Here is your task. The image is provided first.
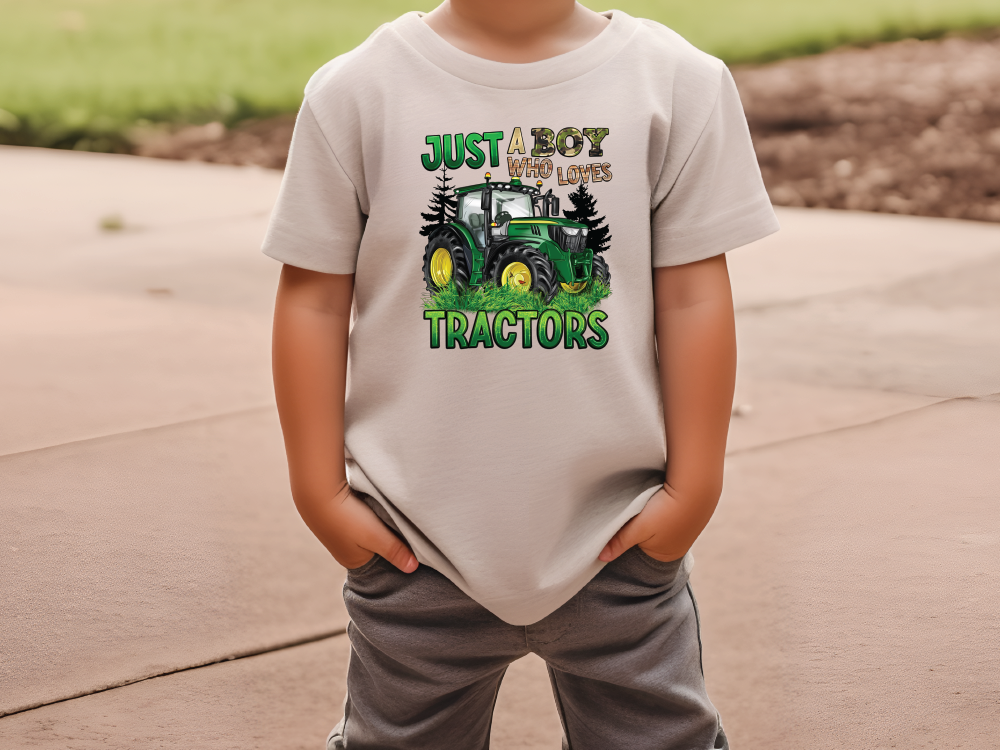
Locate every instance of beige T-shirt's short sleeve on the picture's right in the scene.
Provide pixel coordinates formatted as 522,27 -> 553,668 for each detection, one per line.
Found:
651,66 -> 779,267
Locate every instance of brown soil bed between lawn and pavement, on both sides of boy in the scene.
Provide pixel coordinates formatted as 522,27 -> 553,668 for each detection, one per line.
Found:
136,34 -> 1000,221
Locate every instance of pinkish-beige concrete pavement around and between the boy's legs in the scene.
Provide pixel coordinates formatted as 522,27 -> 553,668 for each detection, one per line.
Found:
0,148 -> 1000,750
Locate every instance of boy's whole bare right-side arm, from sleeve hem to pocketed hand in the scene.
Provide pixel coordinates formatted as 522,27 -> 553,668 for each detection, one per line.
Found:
600,254 -> 736,562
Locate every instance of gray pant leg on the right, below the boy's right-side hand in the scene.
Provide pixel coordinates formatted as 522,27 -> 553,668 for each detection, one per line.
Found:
528,547 -> 728,750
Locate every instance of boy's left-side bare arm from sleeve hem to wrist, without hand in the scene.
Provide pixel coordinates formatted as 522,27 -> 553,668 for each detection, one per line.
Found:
272,266 -> 354,516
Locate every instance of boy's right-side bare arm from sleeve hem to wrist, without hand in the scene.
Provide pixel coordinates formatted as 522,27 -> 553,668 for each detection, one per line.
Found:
654,255 -> 736,524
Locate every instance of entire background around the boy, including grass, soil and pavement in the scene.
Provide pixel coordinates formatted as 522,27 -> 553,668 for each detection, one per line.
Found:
0,0 -> 1000,750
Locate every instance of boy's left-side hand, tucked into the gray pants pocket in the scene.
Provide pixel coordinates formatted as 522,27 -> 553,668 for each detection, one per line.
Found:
300,485 -> 418,573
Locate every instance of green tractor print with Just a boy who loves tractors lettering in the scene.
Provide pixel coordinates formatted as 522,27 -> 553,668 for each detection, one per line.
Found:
420,127 -> 613,349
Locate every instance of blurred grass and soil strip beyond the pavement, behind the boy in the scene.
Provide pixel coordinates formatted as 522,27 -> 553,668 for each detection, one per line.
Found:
0,0 -> 1000,221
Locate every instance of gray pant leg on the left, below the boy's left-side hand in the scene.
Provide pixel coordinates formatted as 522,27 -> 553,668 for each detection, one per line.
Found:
327,556 -> 527,750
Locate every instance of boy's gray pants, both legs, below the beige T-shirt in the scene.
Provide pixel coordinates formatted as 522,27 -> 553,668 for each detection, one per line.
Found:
327,547 -> 729,750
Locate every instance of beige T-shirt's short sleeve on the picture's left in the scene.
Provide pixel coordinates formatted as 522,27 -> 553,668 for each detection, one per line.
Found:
261,100 -> 366,273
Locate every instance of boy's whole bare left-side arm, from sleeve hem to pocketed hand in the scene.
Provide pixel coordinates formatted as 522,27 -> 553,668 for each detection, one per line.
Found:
272,265 -> 417,573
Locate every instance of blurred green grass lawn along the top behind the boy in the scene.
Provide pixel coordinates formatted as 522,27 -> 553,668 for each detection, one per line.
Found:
0,0 -> 1000,150
